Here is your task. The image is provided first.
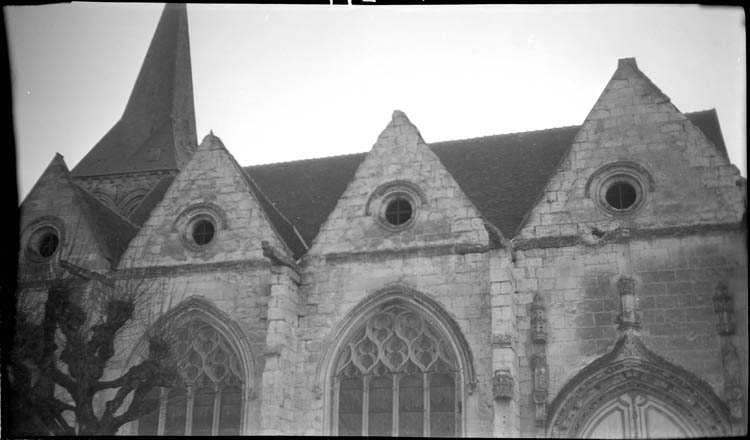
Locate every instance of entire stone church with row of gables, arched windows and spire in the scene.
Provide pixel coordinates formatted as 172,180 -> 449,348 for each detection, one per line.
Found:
18,5 -> 748,437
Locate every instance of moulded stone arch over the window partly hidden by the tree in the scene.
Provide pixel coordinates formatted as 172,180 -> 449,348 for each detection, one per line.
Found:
122,295 -> 261,434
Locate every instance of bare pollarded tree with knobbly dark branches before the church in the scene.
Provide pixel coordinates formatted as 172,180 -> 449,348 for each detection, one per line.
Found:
6,261 -> 180,435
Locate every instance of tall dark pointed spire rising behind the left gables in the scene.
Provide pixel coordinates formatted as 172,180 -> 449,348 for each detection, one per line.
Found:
72,4 -> 197,177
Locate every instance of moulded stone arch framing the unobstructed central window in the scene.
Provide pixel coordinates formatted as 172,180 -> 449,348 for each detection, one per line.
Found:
314,284 -> 477,435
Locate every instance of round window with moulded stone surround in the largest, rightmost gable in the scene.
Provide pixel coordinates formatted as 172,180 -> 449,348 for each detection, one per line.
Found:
586,162 -> 653,215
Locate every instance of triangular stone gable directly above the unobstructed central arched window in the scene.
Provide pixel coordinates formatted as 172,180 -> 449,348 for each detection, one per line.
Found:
309,110 -> 489,254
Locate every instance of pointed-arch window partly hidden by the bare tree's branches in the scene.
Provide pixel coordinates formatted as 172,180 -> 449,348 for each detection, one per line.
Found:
138,318 -> 243,435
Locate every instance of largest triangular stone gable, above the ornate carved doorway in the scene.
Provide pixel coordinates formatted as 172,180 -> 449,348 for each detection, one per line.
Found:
521,58 -> 743,238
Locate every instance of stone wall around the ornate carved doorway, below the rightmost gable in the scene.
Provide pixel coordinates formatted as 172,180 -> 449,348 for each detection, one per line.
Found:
512,232 -> 748,434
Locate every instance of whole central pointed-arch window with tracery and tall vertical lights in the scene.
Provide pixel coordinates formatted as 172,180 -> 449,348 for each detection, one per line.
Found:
333,303 -> 461,437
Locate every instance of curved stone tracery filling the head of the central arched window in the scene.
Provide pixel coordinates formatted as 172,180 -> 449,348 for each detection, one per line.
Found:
336,305 -> 456,376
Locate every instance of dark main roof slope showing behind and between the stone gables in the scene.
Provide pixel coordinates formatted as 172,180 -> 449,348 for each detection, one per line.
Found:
244,110 -> 727,248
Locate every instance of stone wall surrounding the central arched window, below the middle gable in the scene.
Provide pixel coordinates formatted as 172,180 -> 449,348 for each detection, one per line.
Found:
295,252 -> 500,436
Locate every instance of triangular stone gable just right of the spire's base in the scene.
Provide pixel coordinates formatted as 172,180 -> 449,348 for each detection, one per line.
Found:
120,134 -> 292,268
